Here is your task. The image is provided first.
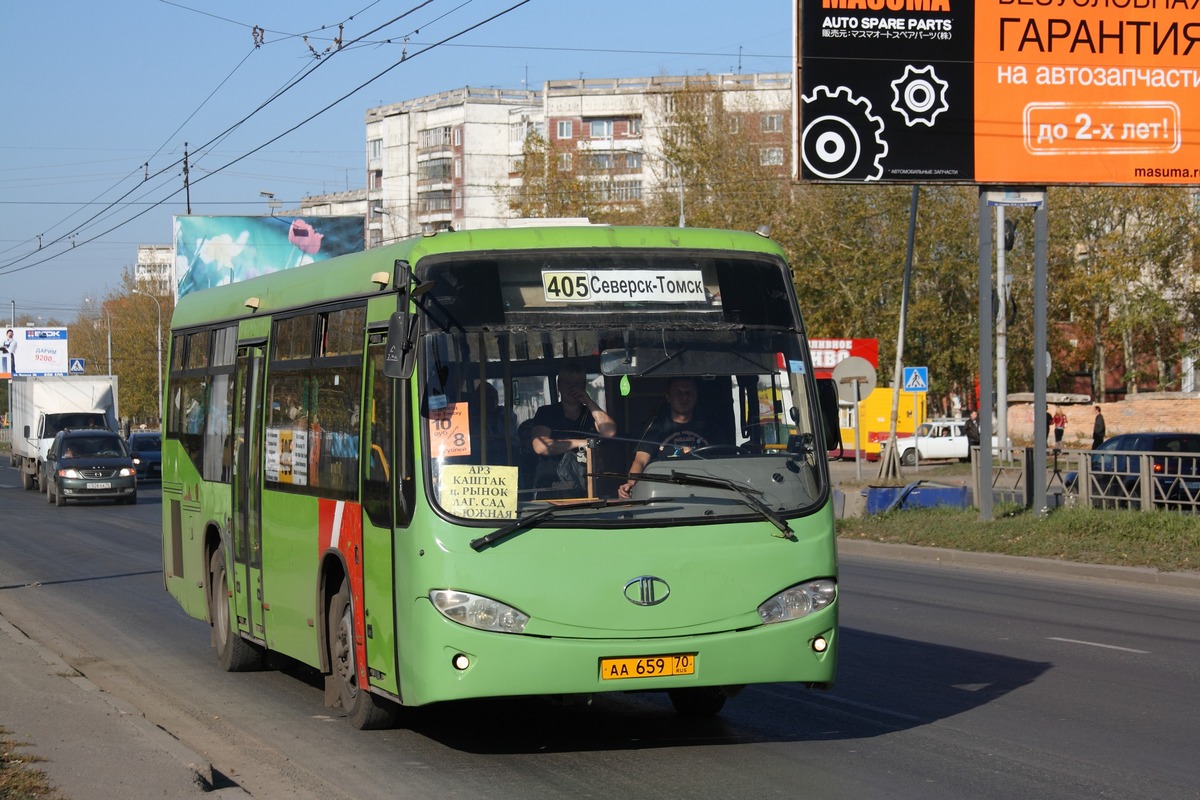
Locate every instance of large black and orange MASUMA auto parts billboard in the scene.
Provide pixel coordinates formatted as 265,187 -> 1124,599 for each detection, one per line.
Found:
794,0 -> 1200,186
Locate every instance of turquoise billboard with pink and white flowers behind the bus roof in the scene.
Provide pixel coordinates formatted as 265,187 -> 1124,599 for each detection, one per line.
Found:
174,216 -> 365,299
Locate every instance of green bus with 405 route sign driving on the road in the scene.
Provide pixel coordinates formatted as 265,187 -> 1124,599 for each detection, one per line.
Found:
162,225 -> 838,728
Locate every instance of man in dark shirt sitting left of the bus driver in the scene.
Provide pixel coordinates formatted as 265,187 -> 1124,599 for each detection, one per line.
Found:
530,361 -> 617,499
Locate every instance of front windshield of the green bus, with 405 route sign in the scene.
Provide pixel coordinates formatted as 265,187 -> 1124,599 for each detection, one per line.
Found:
419,251 -> 827,530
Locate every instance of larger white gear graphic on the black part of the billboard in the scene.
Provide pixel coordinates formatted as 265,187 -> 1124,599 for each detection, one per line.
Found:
800,86 -> 888,181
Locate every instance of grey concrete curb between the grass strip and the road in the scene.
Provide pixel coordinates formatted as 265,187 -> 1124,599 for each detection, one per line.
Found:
838,537 -> 1200,591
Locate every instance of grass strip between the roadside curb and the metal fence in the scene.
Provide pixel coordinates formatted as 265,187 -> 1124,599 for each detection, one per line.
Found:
838,506 -> 1200,572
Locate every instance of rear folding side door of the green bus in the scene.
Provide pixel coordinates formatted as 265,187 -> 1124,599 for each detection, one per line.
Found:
233,344 -> 266,642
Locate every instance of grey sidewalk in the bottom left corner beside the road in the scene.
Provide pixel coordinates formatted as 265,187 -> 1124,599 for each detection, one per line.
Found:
0,616 -> 250,800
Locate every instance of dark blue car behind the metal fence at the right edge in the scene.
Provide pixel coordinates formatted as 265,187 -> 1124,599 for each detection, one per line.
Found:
1063,432 -> 1200,505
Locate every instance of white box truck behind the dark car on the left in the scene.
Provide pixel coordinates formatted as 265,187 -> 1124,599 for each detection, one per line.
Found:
8,375 -> 120,489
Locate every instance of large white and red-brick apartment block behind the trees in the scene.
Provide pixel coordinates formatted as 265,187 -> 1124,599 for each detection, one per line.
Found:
360,73 -> 792,247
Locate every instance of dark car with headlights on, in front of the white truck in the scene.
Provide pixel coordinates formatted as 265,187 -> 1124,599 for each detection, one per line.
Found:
38,428 -> 138,506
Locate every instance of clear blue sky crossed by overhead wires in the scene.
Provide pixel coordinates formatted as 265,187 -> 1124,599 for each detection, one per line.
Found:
0,0 -> 792,321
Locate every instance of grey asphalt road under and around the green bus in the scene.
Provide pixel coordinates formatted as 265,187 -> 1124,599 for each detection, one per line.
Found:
0,465 -> 1200,800
